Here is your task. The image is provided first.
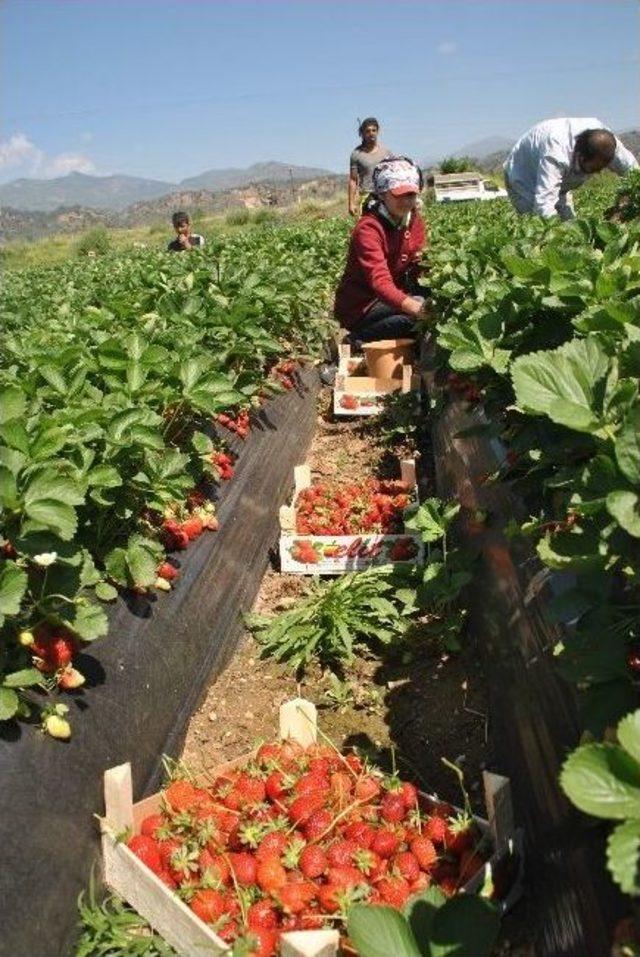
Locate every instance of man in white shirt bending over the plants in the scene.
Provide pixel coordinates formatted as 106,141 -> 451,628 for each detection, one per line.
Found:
504,117 -> 638,220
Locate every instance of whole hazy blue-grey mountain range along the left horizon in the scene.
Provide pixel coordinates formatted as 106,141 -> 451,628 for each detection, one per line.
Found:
0,162 -> 338,212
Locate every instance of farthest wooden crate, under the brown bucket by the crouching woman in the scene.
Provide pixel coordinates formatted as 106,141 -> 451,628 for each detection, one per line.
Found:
333,345 -> 420,416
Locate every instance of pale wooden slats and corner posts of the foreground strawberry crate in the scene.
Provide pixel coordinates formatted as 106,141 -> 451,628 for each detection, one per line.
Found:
99,698 -> 521,957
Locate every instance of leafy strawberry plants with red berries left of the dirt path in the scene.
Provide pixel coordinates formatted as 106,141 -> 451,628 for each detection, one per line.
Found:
0,223 -> 344,736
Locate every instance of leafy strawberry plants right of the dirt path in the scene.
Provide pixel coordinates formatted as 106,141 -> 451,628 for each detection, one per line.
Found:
430,177 -> 640,893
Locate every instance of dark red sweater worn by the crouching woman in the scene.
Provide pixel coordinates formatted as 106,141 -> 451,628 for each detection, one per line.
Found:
334,211 -> 425,329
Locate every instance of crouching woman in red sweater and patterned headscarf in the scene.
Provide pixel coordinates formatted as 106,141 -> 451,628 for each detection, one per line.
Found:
334,156 -> 426,342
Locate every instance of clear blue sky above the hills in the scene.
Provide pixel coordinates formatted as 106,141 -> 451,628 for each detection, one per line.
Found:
0,0 -> 640,181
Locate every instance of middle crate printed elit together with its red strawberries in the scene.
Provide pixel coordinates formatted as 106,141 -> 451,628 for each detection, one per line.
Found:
280,459 -> 424,575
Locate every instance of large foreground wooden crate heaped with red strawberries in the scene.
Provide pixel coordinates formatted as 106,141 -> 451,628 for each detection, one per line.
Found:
101,699 -> 520,957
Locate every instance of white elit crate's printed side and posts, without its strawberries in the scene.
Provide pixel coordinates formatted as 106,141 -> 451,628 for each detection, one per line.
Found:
280,459 -> 424,575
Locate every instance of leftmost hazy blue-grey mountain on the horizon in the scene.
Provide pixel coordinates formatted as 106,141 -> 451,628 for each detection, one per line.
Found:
0,173 -> 174,212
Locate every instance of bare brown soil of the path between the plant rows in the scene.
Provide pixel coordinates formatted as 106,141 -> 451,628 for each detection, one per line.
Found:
182,389 -> 531,957
